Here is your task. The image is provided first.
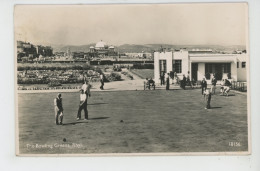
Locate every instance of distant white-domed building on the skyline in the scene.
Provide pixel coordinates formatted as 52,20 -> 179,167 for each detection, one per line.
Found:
89,40 -> 117,57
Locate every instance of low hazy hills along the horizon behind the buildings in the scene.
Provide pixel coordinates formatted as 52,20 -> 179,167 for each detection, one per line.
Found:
51,43 -> 246,53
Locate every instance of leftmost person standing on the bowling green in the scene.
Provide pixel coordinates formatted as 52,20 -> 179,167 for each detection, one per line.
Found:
54,93 -> 63,125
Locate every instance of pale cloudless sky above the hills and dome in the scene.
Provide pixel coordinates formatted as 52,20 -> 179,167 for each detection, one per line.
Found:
14,3 -> 248,45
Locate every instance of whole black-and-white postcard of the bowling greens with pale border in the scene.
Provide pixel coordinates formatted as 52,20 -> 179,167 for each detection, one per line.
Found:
14,3 -> 251,156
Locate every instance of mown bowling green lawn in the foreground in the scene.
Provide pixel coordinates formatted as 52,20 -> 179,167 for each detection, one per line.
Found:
18,89 -> 248,154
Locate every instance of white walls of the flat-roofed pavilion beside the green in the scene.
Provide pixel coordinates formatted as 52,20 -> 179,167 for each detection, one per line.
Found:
154,50 -> 248,83
